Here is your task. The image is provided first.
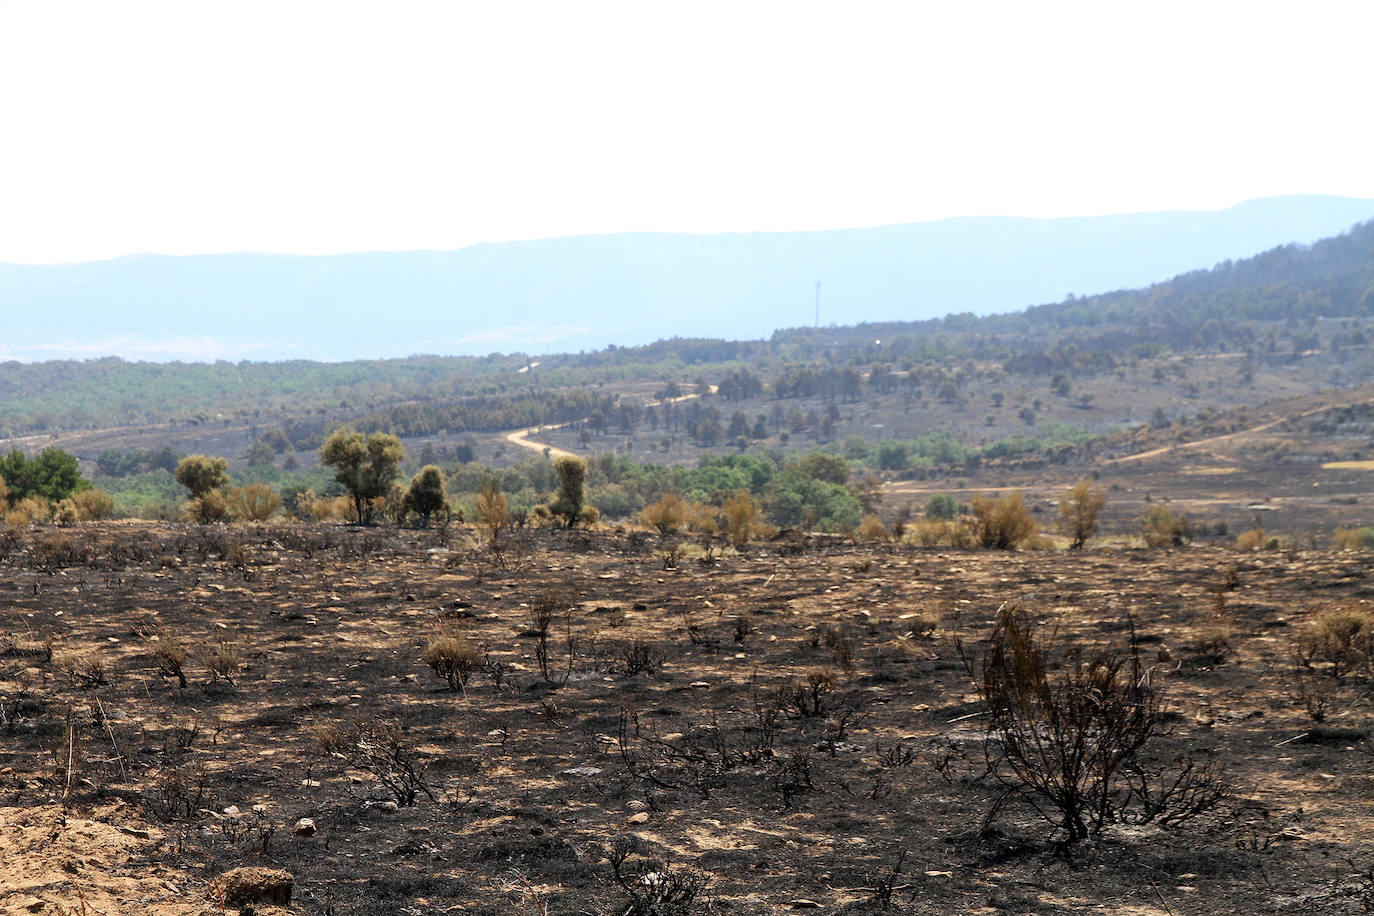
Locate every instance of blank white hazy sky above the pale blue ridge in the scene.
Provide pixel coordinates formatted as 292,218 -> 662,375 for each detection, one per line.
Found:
0,0 -> 1374,262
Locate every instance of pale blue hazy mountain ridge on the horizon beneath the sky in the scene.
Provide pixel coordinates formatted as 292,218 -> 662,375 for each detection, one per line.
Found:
8,196 -> 1374,361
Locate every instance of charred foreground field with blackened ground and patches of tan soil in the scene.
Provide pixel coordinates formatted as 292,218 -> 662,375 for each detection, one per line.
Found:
0,521 -> 1374,916
